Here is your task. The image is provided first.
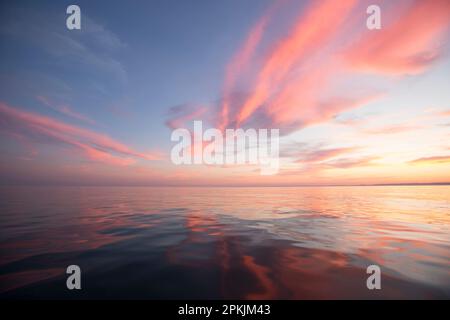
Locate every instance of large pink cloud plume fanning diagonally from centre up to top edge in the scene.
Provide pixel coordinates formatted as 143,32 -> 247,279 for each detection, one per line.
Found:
210,0 -> 381,134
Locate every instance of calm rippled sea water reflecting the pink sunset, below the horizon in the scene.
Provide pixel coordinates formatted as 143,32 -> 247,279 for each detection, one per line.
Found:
0,186 -> 450,299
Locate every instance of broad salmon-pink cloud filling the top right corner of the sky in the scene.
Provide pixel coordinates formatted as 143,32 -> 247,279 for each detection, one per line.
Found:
346,0 -> 450,75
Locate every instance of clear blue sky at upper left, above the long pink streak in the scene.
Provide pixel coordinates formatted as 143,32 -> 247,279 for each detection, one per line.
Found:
0,1 -> 274,148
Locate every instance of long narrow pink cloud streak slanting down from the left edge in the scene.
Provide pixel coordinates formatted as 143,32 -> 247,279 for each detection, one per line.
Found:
0,102 -> 162,165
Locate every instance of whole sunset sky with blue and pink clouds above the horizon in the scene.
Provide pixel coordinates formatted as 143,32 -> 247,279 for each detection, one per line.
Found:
0,0 -> 450,186
